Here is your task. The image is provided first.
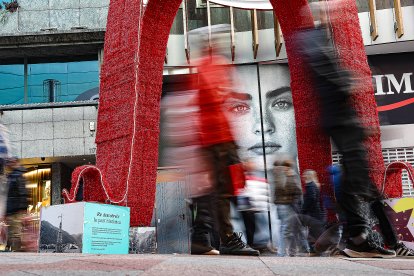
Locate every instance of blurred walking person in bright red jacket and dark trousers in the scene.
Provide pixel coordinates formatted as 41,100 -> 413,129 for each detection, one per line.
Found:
190,24 -> 259,256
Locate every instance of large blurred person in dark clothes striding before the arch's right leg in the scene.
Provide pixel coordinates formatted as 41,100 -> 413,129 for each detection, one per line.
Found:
294,2 -> 395,258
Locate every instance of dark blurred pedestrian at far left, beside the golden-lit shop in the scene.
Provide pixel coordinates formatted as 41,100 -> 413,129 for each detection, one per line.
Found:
6,157 -> 28,251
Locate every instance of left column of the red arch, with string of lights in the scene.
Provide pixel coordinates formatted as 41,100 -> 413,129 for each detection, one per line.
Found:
96,0 -> 181,226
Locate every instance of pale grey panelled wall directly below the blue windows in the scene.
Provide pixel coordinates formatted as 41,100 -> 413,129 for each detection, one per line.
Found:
0,106 -> 97,158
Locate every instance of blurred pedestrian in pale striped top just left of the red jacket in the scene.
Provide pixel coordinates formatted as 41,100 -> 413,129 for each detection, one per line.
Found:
162,89 -> 219,255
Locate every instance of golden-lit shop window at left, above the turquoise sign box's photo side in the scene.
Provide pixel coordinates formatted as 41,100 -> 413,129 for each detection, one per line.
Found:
24,168 -> 51,215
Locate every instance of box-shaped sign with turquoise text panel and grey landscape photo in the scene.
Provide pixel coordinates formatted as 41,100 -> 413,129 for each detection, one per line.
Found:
39,202 -> 130,254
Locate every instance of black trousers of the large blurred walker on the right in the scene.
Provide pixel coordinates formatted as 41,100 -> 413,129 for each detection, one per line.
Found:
327,126 -> 379,237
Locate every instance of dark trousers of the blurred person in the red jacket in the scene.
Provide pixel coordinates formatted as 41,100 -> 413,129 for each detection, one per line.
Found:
206,142 -> 240,241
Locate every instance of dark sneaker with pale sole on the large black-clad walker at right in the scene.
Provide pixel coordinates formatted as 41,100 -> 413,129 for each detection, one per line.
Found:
343,238 -> 396,258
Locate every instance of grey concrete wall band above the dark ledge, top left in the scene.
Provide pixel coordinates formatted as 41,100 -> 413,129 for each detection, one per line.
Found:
0,0 -> 110,35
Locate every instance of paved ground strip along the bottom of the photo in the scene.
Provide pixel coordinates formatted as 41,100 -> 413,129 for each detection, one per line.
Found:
0,253 -> 414,276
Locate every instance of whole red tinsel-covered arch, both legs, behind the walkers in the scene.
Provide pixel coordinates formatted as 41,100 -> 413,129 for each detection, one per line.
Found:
67,0 -> 394,226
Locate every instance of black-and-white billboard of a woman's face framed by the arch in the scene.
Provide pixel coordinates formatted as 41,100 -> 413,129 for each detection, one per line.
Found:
225,64 -> 297,174
